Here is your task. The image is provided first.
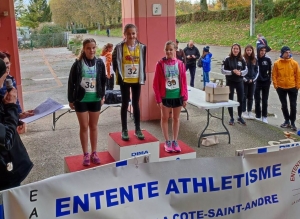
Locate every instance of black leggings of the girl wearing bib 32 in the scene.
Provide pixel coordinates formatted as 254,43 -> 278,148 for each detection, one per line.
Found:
120,83 -> 141,130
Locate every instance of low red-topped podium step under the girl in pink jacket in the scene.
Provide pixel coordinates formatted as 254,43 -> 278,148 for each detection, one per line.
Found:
159,140 -> 196,162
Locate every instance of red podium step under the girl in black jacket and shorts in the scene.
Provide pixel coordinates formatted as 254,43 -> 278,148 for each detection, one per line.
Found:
64,151 -> 115,173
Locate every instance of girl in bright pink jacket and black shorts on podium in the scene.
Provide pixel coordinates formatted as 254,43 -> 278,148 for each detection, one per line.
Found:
153,41 -> 188,152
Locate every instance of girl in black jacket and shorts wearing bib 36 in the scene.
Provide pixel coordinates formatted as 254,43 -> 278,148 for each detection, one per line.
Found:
68,38 -> 106,166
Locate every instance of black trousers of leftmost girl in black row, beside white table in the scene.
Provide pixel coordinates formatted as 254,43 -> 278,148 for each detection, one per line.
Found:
226,80 -> 244,119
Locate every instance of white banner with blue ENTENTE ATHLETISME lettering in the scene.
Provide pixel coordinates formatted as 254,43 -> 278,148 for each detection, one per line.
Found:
4,147 -> 300,219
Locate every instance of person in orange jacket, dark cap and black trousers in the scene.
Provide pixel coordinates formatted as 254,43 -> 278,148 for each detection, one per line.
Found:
272,46 -> 300,131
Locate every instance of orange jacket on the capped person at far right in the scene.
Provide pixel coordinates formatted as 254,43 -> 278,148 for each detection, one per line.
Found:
272,58 -> 300,89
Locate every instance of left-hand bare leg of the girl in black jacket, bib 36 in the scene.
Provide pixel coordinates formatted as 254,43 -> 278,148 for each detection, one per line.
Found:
76,112 -> 89,154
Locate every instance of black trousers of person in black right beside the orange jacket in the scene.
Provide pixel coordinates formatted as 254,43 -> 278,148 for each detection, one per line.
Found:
254,81 -> 271,118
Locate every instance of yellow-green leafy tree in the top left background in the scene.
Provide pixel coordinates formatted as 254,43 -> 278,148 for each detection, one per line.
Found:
20,0 -> 52,28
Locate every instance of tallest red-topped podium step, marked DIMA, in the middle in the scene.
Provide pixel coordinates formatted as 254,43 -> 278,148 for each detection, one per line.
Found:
108,130 -> 159,162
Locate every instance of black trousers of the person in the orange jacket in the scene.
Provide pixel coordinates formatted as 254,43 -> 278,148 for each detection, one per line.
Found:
276,88 -> 298,124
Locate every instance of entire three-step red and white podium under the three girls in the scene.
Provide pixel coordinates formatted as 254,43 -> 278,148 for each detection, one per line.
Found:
64,130 -> 196,173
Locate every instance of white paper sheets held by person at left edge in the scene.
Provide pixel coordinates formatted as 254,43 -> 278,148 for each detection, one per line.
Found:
21,98 -> 63,123
